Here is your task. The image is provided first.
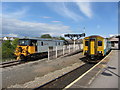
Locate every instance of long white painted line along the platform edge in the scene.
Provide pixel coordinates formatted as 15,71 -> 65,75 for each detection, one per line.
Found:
63,51 -> 112,90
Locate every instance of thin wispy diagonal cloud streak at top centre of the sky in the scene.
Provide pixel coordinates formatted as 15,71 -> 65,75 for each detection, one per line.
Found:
47,2 -> 82,21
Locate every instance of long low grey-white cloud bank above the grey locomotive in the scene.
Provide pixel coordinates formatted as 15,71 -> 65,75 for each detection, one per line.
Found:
2,18 -> 71,37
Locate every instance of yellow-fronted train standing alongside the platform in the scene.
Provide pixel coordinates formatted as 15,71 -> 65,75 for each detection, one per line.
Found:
83,35 -> 111,59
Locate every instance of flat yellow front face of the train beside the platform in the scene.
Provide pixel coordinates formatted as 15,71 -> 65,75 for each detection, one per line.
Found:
83,36 -> 104,60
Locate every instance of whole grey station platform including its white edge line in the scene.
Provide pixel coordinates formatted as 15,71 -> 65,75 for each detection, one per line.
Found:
65,50 -> 120,90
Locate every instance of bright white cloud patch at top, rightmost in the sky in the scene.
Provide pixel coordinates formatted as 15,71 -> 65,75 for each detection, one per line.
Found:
76,2 -> 93,18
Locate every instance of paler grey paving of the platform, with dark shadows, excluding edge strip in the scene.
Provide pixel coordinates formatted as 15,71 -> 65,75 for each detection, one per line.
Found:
90,50 -> 120,88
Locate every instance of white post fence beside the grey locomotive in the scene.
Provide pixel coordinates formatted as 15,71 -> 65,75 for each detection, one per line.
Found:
48,44 -> 83,60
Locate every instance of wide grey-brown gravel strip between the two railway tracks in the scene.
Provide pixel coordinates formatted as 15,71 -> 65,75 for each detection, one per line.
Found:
2,53 -> 84,88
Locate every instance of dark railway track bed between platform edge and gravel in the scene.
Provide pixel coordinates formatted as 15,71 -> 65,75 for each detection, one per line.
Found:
34,63 -> 95,90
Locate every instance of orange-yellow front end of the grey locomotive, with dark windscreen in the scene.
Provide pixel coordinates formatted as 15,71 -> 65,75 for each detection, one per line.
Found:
14,39 -> 35,60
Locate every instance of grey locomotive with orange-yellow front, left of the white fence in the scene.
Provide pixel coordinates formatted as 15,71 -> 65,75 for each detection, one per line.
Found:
14,38 -> 64,60
